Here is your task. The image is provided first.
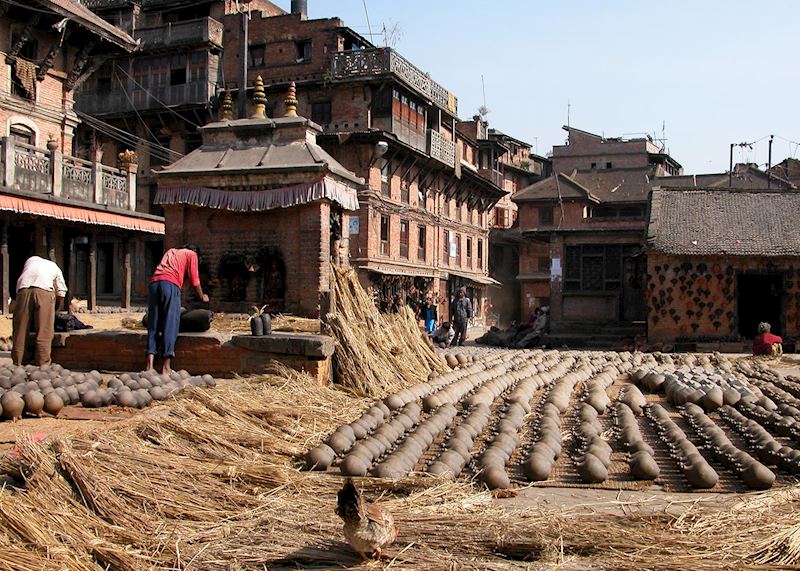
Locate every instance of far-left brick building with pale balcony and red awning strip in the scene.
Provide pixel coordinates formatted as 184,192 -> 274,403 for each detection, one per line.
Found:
0,0 -> 164,312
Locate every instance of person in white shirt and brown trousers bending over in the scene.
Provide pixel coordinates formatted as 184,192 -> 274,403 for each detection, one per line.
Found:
11,256 -> 67,366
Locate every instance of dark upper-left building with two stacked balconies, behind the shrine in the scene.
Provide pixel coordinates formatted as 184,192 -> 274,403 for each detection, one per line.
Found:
75,0 -> 285,213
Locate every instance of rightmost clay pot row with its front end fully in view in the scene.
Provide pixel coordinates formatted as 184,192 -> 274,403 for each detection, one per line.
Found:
684,403 -> 775,490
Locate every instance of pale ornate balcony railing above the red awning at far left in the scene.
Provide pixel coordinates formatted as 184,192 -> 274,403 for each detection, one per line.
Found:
0,137 -> 136,210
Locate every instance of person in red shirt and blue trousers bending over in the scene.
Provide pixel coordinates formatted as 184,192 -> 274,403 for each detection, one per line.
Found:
147,244 -> 208,374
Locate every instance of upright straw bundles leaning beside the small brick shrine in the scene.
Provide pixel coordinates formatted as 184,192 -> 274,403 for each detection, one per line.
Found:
328,267 -> 447,397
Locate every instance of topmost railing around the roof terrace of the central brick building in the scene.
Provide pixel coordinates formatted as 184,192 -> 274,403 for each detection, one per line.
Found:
331,48 -> 458,115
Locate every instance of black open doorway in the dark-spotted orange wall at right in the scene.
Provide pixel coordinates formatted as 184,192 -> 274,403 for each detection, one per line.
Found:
736,274 -> 783,339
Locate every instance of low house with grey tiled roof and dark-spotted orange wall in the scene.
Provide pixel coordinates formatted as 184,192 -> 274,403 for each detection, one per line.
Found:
647,188 -> 800,351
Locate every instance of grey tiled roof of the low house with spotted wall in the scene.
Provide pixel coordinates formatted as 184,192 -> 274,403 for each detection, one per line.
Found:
647,189 -> 800,257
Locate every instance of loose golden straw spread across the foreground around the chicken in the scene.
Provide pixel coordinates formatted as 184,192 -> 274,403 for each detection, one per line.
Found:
0,370 -> 800,571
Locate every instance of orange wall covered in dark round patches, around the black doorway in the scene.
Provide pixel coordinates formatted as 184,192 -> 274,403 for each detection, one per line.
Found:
647,252 -> 800,342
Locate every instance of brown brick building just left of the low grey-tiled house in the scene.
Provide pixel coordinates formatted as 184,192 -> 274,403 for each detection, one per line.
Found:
511,127 -> 681,327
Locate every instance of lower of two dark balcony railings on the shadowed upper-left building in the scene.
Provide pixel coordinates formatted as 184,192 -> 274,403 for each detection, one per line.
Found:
75,81 -> 214,115
